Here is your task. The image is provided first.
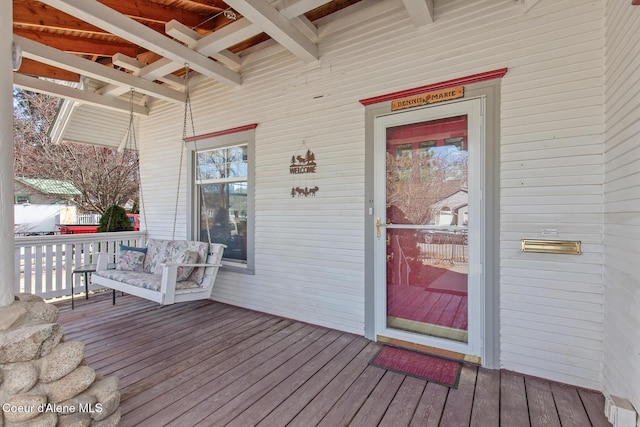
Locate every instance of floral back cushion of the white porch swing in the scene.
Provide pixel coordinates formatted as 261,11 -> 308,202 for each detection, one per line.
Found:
143,239 -> 209,284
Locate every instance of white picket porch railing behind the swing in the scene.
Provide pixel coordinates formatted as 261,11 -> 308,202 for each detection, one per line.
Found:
14,231 -> 145,299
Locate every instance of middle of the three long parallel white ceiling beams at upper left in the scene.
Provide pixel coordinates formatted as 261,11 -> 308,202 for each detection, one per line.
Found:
13,36 -> 184,103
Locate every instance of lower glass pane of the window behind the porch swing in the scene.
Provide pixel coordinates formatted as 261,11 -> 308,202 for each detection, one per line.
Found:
199,182 -> 247,263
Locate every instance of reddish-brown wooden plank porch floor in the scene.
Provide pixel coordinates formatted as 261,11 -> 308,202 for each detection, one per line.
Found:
57,293 -> 610,427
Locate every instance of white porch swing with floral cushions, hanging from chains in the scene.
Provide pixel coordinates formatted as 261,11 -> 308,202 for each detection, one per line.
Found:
91,65 -> 226,305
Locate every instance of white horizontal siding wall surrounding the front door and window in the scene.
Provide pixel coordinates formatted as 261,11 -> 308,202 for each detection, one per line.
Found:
141,0 -> 604,388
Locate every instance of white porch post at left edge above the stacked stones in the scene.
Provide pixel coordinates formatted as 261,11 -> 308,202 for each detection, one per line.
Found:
0,0 -> 15,307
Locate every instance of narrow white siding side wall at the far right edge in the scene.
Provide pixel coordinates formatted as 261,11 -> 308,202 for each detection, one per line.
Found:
604,1 -> 640,410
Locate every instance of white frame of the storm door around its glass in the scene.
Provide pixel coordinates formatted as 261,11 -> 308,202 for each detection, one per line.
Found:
374,98 -> 484,358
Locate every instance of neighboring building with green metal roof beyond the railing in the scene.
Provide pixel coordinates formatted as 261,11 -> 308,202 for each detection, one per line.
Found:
14,177 -> 82,205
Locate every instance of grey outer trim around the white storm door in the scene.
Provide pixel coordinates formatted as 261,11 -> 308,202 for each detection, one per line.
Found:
364,75 -> 503,368
